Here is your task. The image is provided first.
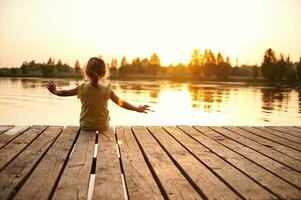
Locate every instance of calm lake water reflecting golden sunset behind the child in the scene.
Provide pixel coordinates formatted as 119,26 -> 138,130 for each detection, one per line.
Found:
0,78 -> 301,125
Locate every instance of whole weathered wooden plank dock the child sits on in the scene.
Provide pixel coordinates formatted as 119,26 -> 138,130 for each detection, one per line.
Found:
0,125 -> 301,200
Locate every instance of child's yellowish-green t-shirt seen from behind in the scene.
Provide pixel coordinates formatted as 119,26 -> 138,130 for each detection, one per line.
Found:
77,83 -> 111,129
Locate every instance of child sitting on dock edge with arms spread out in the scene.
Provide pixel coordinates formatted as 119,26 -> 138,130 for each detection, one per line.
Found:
46,57 -> 149,131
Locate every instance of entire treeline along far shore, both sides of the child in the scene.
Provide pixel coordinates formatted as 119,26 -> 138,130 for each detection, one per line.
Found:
0,49 -> 301,82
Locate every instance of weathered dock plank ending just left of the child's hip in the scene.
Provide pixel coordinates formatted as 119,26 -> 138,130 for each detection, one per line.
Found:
14,126 -> 79,200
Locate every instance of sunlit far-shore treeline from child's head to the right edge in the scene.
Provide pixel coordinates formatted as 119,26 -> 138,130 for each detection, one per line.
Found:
110,49 -> 301,82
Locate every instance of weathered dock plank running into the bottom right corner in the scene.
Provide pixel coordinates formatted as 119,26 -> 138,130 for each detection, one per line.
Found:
180,126 -> 301,199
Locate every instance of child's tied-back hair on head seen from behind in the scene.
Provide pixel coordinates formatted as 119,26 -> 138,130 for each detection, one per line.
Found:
86,57 -> 107,85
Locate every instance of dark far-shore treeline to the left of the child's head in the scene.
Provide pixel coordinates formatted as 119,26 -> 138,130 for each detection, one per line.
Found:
0,57 -> 82,77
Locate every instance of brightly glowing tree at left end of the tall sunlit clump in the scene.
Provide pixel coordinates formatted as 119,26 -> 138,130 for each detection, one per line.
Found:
188,49 -> 202,79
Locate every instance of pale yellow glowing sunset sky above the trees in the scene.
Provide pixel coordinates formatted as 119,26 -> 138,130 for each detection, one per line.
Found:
0,0 -> 301,67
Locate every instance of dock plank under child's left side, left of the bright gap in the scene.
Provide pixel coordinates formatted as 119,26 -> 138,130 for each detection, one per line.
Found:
52,130 -> 95,200
